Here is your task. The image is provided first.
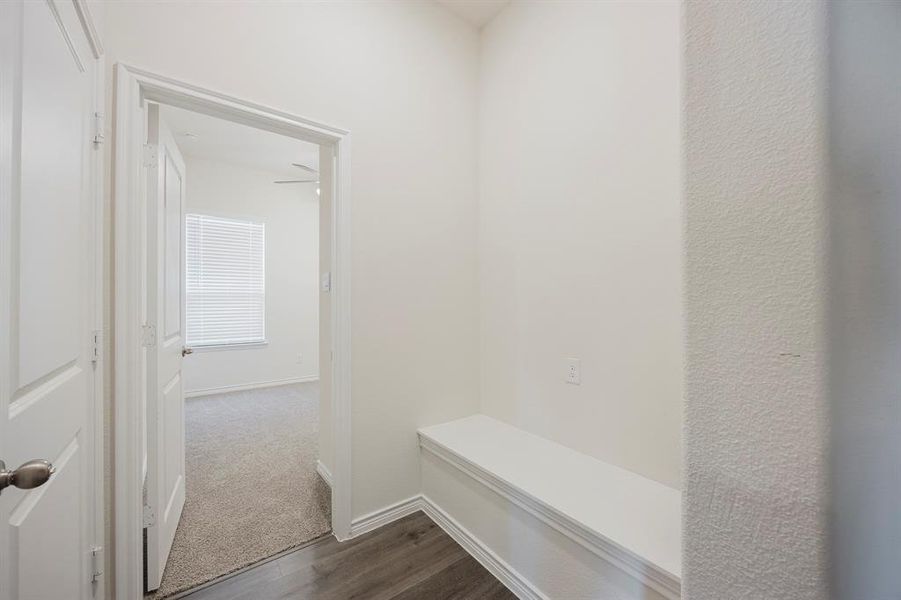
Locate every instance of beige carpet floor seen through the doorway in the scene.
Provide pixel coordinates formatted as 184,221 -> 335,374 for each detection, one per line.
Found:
148,383 -> 331,600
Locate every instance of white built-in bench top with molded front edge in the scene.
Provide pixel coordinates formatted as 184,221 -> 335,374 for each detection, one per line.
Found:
419,415 -> 681,598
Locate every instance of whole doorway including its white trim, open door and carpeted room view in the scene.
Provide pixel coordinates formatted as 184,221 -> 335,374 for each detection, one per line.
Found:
115,66 -> 350,598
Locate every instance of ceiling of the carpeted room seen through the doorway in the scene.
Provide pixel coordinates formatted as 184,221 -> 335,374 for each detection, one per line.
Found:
160,105 -> 319,179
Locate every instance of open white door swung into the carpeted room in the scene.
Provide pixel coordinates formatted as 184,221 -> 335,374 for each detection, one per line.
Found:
146,104 -> 185,591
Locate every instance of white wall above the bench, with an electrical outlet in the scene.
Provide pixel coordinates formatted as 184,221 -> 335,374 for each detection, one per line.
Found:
479,2 -> 682,487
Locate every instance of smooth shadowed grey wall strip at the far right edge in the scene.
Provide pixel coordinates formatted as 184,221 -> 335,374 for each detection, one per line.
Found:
828,1 -> 901,600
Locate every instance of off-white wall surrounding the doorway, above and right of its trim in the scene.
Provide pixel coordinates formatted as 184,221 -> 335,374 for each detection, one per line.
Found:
103,0 -> 478,516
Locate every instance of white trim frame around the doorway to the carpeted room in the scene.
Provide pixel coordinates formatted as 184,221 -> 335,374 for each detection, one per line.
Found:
113,63 -> 351,600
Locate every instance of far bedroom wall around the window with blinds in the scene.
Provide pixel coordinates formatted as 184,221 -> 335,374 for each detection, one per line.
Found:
184,156 -> 319,394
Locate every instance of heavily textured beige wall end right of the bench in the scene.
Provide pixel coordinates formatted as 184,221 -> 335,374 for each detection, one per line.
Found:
683,1 -> 828,600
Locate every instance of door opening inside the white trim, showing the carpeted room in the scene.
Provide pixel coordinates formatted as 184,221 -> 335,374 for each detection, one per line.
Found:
143,103 -> 331,598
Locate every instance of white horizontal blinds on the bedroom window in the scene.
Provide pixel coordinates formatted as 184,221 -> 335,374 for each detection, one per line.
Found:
185,214 -> 266,346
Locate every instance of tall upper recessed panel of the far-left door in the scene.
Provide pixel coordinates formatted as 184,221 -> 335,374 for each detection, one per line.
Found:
18,2 -> 91,386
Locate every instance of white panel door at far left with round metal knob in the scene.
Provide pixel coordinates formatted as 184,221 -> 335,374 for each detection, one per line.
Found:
0,0 -> 99,600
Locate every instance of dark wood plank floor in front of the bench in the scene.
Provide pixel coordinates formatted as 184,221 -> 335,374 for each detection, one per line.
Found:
184,513 -> 515,600
